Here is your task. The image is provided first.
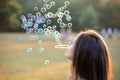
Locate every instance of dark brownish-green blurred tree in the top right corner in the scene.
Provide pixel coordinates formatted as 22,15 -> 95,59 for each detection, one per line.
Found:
99,0 -> 120,28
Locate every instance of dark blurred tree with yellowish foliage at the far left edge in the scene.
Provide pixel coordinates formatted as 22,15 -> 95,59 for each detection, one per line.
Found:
0,0 -> 20,31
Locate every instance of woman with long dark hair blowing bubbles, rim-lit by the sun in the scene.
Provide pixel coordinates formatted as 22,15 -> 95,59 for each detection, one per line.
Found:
65,30 -> 111,80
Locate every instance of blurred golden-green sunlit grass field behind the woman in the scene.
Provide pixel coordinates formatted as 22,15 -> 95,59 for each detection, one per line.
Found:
0,33 -> 120,80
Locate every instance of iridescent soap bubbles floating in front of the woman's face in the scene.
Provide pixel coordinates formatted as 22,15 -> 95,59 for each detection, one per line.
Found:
21,0 -> 72,64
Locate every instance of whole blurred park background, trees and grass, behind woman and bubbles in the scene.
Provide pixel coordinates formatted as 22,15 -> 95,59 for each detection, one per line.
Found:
0,0 -> 120,80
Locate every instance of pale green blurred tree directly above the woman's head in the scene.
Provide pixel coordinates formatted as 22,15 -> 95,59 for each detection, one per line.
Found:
79,6 -> 98,29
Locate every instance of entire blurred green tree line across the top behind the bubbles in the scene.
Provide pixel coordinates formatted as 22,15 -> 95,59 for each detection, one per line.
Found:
0,0 -> 120,31
